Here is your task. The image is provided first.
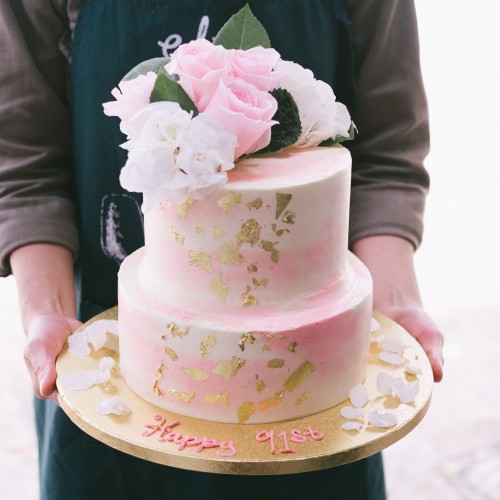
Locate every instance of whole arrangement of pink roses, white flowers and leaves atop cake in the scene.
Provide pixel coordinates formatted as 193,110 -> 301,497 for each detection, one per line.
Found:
103,5 -> 355,208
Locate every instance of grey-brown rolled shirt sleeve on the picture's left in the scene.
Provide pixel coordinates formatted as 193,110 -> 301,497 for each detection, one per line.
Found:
0,0 -> 78,276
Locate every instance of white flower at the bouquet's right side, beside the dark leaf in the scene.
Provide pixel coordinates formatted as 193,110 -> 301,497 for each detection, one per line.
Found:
274,61 -> 351,147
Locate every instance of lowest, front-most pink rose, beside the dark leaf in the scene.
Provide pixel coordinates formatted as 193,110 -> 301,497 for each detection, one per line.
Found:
205,78 -> 278,159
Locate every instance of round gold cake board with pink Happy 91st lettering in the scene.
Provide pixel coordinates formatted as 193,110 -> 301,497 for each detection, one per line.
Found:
56,307 -> 433,475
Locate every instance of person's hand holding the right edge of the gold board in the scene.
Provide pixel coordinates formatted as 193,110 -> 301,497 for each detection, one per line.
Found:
377,306 -> 444,382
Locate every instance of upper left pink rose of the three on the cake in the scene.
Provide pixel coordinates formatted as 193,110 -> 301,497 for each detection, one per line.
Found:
165,38 -> 231,112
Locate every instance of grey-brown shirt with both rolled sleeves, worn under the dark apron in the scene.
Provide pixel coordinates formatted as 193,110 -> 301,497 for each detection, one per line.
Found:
0,0 -> 429,276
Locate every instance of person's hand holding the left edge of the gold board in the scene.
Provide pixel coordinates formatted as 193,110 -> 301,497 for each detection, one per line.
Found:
24,314 -> 81,403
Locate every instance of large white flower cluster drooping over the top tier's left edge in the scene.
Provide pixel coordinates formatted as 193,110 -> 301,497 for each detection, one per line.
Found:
120,101 -> 236,212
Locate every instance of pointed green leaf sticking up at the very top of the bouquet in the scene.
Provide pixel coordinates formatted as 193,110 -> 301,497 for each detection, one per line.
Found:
214,4 -> 271,50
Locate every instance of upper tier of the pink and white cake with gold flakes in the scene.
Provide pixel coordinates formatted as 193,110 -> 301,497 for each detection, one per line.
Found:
139,147 -> 351,314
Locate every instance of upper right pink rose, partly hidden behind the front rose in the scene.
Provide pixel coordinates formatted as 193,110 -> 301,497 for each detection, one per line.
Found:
229,47 -> 283,92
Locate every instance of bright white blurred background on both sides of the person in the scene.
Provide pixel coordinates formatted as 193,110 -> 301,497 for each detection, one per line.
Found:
0,0 -> 500,500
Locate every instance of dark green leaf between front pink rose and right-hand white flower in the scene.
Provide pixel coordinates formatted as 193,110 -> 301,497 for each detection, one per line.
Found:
253,89 -> 302,155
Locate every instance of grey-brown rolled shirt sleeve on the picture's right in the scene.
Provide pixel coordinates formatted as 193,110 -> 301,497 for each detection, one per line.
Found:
344,0 -> 429,248
